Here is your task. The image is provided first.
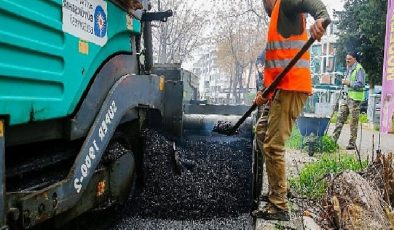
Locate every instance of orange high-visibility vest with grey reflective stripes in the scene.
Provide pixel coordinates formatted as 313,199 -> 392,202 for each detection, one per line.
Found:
264,0 -> 312,95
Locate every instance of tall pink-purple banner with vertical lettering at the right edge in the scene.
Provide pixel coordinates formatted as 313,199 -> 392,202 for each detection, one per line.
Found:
380,0 -> 394,133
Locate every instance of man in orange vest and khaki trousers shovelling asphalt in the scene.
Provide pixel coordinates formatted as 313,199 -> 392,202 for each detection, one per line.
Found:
252,0 -> 330,221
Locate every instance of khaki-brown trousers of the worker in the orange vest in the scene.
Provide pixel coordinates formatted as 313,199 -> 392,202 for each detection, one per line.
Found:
256,91 -> 308,210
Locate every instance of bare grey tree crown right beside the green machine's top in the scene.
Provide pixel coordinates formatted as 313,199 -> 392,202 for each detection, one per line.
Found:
152,0 -> 207,63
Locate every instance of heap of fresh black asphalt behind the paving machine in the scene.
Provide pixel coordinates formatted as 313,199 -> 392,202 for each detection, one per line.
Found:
113,130 -> 252,229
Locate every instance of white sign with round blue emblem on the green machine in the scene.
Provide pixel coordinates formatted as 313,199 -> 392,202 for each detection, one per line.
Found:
62,0 -> 108,46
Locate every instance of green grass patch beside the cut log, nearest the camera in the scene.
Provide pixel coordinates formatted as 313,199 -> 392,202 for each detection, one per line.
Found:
289,154 -> 368,199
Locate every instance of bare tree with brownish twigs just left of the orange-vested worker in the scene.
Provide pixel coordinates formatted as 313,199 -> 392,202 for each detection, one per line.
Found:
214,0 -> 268,103
